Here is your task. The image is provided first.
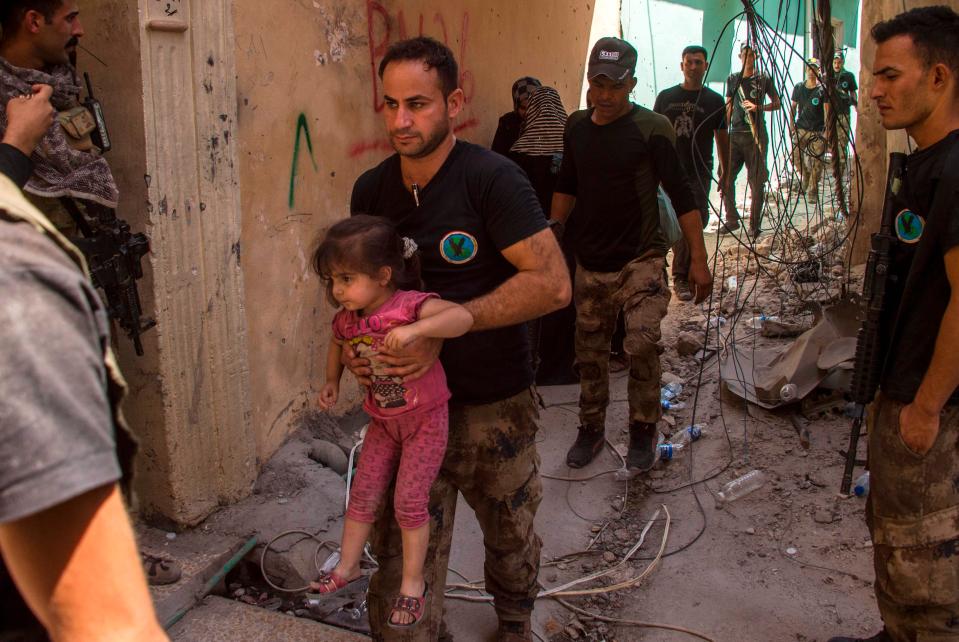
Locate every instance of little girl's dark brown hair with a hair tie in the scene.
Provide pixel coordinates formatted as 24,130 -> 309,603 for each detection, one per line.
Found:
310,214 -> 423,306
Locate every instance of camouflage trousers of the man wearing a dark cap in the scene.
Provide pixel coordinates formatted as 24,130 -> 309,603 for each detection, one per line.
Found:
573,256 -> 670,428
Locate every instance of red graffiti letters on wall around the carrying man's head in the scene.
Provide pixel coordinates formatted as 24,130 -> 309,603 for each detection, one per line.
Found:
366,0 -> 474,112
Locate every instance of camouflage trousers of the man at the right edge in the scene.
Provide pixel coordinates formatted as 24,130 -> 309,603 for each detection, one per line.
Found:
866,396 -> 959,642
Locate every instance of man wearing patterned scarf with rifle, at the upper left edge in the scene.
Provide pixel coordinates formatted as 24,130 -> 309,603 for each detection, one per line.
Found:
0,0 -> 181,597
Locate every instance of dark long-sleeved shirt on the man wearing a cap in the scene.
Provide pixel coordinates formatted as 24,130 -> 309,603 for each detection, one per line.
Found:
556,105 -> 697,272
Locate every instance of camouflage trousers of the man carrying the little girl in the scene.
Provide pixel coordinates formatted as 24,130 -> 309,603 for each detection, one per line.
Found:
367,390 -> 543,641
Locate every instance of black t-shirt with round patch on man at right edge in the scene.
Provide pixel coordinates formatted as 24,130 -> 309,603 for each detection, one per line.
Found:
881,130 -> 959,403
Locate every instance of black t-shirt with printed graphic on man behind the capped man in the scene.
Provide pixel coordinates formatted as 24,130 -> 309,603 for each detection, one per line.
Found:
653,85 -> 726,178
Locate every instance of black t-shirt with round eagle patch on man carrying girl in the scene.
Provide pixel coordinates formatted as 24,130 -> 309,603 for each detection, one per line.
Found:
350,141 -> 546,404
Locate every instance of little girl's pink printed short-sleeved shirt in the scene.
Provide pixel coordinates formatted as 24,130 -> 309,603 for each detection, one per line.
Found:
333,290 -> 450,419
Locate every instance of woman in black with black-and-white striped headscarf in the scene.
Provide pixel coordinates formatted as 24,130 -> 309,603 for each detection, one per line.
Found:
509,87 -> 578,385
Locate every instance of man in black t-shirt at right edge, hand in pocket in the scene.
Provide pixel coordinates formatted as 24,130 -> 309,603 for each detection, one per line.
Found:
830,7 -> 959,642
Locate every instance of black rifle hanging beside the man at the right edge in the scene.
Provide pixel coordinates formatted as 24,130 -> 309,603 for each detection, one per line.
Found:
840,152 -> 906,495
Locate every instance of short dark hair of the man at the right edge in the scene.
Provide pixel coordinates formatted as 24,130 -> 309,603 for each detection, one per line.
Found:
872,6 -> 959,76
